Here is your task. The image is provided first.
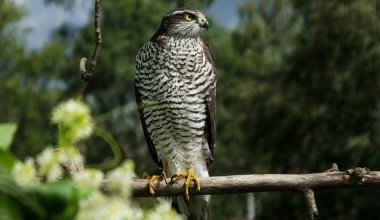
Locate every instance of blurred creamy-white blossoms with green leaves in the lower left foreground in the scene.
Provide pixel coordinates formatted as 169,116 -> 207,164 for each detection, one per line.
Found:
0,100 -> 180,220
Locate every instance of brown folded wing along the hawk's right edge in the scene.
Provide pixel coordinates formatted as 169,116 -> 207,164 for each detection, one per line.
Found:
202,40 -> 216,167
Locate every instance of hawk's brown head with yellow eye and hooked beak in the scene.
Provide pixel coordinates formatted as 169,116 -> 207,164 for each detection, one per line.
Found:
158,8 -> 209,38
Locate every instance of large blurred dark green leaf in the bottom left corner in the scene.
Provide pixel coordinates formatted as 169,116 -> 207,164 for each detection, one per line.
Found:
0,173 -> 84,220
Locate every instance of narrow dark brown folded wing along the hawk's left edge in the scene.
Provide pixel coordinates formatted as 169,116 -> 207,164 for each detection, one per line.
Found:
135,85 -> 162,168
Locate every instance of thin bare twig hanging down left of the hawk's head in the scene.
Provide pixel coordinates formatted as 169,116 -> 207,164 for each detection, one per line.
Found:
77,0 -> 102,97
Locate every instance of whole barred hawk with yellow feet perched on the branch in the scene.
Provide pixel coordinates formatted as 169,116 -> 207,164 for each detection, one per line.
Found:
135,8 -> 216,219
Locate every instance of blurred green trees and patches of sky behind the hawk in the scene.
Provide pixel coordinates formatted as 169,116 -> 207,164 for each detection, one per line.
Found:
0,0 -> 380,219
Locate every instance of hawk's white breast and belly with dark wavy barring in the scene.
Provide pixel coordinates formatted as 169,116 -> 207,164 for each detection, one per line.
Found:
136,39 -> 215,161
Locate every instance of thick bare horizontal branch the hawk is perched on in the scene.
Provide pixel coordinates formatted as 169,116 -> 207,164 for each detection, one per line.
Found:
124,168 -> 374,219
